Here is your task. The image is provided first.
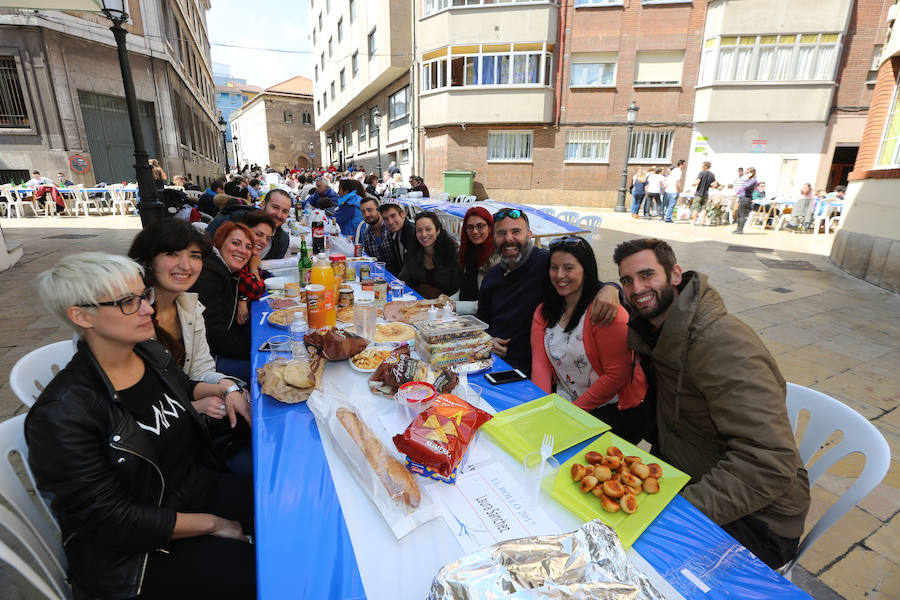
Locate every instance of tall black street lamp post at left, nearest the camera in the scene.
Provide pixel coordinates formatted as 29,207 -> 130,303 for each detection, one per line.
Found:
102,0 -> 163,227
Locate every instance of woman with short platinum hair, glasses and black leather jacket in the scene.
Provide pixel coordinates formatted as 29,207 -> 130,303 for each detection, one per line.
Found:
25,252 -> 256,600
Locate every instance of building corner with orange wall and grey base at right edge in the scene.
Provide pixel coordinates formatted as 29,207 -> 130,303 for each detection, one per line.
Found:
831,3 -> 900,292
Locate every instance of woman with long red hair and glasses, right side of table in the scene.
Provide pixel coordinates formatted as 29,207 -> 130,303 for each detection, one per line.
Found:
453,206 -> 499,315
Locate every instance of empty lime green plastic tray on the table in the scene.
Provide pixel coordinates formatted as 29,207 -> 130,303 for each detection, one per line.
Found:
481,394 -> 610,462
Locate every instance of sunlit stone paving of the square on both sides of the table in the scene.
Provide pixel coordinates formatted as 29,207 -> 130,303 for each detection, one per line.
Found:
0,213 -> 900,600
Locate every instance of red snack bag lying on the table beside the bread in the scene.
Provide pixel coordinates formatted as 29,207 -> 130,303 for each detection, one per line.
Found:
394,394 -> 491,477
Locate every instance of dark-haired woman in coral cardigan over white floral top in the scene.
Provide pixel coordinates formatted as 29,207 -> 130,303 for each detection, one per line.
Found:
531,237 -> 652,444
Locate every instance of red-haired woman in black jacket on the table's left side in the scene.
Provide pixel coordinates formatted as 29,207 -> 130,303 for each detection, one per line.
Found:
190,221 -> 253,381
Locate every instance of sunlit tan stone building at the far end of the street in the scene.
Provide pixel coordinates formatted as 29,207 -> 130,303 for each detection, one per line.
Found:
231,75 -> 320,170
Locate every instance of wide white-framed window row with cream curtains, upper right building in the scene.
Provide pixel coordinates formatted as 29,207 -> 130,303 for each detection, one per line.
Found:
700,31 -> 844,85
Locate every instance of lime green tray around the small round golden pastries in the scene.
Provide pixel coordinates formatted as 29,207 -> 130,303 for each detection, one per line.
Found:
550,432 -> 691,549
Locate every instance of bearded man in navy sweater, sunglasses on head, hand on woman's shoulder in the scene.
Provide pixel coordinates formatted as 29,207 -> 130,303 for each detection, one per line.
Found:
476,208 -> 620,376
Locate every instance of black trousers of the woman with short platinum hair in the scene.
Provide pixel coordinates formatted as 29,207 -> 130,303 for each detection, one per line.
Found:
137,473 -> 256,600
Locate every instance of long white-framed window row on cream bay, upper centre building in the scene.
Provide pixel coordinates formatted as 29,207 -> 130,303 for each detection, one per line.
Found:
422,44 -> 553,92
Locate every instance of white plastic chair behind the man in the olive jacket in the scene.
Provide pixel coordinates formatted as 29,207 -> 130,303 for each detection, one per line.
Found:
780,383 -> 891,576
